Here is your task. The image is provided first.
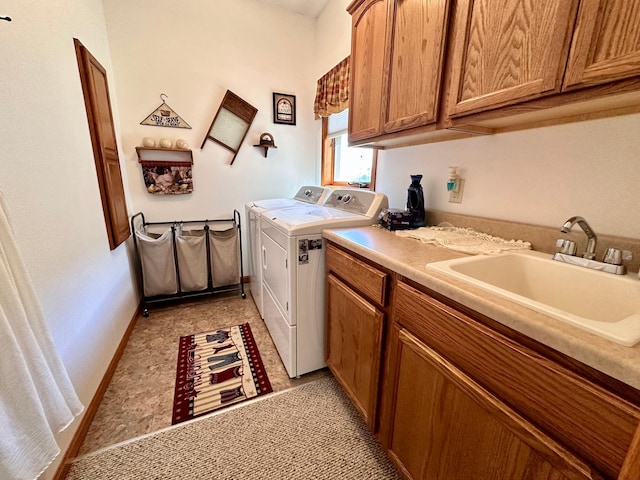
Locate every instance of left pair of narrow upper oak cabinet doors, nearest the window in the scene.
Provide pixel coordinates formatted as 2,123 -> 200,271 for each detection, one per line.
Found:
348,0 -> 450,143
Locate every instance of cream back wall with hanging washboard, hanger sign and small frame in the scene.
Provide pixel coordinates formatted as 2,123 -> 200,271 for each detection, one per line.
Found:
104,0 -> 319,229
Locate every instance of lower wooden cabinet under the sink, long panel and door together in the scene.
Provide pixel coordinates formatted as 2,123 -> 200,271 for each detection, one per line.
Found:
381,282 -> 640,479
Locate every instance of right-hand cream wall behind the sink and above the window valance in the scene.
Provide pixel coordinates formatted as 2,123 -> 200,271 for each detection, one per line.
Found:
318,0 -> 640,240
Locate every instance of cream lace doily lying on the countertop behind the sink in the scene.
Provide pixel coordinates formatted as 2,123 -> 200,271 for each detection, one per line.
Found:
396,227 -> 531,255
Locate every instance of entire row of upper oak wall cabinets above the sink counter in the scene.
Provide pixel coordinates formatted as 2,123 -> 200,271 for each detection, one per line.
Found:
347,0 -> 640,148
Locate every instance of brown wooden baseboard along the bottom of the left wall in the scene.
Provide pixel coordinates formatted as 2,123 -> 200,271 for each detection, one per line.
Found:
53,303 -> 142,480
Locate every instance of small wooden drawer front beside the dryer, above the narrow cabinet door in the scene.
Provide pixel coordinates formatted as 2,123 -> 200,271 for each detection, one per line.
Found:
327,245 -> 389,305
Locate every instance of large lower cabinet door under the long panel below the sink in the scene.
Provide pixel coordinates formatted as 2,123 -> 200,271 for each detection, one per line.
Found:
388,327 -> 598,480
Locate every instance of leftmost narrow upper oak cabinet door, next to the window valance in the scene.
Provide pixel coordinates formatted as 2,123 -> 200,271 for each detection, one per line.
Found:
349,0 -> 387,142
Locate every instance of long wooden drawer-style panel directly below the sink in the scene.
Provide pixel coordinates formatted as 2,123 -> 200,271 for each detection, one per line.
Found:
393,283 -> 640,478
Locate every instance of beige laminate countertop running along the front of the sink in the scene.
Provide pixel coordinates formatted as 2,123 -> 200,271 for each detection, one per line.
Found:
323,226 -> 640,389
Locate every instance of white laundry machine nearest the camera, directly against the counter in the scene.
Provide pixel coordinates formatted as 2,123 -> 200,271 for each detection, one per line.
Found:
261,189 -> 388,378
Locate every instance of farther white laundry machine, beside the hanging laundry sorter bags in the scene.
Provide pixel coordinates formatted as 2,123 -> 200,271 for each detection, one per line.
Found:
245,186 -> 331,318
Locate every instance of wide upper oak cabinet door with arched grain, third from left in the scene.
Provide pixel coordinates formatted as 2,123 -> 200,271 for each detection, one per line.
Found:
448,0 -> 578,117
